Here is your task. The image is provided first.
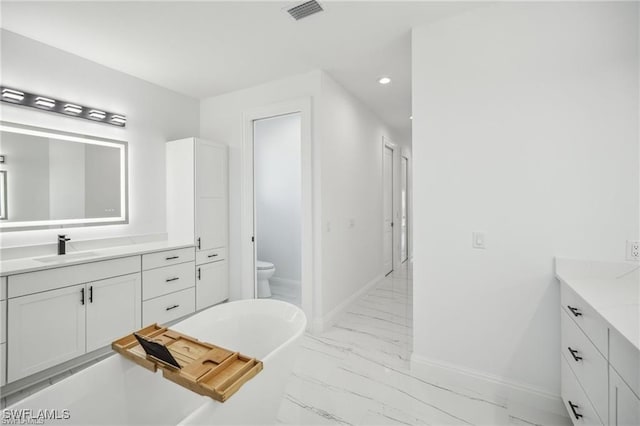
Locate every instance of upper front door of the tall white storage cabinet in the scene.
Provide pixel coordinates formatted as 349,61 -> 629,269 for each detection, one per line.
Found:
195,140 -> 228,250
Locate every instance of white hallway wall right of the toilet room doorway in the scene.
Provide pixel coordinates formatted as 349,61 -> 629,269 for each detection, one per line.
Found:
320,73 -> 400,325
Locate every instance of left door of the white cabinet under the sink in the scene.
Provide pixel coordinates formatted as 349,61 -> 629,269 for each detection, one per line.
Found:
7,284 -> 87,382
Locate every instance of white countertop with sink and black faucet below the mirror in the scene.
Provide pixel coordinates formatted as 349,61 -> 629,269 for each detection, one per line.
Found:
0,241 -> 194,276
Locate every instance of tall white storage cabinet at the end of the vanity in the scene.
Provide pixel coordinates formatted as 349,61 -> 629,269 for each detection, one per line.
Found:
167,138 -> 229,310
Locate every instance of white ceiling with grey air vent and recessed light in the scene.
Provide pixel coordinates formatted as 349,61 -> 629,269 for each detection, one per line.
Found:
0,1 -> 470,143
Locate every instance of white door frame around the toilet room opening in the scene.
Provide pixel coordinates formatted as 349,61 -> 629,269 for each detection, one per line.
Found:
240,97 -> 318,327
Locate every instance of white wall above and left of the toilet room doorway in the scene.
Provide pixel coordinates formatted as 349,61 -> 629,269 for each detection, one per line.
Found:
200,71 -> 320,300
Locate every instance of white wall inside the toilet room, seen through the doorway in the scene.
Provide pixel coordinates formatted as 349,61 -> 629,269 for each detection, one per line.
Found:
254,113 -> 302,285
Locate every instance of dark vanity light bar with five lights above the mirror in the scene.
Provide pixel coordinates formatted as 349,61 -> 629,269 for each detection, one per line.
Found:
0,86 -> 127,127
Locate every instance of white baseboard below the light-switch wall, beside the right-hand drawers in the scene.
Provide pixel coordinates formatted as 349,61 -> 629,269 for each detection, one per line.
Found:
411,353 -> 567,416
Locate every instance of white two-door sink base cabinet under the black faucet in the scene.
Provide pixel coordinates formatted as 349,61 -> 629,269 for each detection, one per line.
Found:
7,256 -> 141,382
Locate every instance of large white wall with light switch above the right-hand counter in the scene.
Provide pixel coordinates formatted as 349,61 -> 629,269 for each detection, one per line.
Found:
412,3 -> 640,395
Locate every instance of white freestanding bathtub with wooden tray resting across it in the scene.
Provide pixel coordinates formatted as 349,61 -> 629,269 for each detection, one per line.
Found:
3,299 -> 307,425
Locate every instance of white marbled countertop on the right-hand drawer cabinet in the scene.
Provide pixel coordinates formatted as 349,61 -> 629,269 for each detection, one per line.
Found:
556,258 -> 640,350
